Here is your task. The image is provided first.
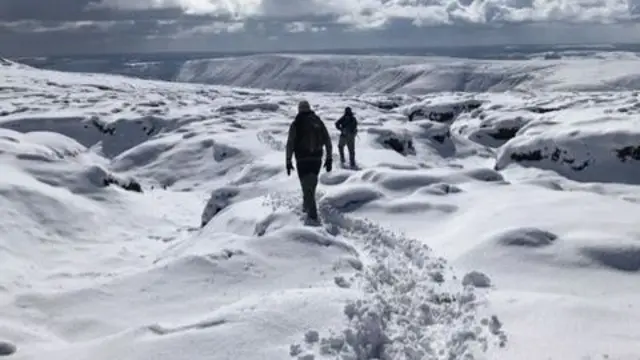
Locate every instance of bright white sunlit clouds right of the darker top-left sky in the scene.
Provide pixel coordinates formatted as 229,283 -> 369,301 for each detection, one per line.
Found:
92,0 -> 640,29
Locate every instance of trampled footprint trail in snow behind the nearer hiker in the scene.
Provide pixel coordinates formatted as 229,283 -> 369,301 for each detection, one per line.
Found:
266,193 -> 506,360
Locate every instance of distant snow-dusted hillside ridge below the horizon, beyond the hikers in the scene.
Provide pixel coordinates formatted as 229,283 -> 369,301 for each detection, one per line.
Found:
173,52 -> 640,95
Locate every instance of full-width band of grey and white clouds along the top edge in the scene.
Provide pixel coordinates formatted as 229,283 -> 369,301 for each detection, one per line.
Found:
0,0 -> 640,29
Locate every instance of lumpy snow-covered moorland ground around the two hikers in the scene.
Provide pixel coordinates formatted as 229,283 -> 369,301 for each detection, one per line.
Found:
0,57 -> 640,360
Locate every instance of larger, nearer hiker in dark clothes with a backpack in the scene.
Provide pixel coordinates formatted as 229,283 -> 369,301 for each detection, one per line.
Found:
286,100 -> 333,221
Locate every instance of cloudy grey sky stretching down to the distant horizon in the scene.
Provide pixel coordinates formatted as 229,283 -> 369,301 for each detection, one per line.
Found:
0,0 -> 640,56
